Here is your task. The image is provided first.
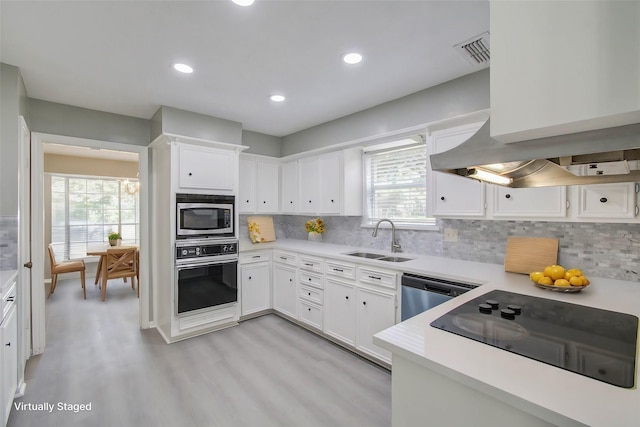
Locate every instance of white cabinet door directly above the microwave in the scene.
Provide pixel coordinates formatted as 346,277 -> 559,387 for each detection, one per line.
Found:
178,144 -> 238,192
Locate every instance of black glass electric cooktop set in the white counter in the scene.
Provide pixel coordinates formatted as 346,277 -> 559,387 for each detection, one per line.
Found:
431,290 -> 638,388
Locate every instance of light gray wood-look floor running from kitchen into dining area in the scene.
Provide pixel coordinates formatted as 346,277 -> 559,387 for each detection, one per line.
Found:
8,278 -> 391,427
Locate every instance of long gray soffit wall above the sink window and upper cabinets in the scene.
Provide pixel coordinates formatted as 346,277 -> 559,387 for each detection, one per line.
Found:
282,68 -> 489,156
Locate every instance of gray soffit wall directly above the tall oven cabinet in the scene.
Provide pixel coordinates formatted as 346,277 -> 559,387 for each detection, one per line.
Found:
151,106 -> 242,145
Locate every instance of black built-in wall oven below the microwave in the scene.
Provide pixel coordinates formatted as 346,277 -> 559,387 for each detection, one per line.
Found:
174,239 -> 238,317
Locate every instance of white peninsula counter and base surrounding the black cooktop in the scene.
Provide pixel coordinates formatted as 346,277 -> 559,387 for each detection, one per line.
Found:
374,275 -> 640,427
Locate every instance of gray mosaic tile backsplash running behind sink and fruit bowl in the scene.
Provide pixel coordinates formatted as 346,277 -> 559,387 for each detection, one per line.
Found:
240,215 -> 640,282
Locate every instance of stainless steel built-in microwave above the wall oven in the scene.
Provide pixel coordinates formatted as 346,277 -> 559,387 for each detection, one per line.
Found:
176,194 -> 235,239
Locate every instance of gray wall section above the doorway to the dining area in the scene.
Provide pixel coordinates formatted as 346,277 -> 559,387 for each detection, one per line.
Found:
29,99 -> 150,146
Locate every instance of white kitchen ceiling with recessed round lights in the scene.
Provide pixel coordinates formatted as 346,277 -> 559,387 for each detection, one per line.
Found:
0,0 -> 489,136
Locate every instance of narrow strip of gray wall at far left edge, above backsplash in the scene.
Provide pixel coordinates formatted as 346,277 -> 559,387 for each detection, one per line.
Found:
0,63 -> 29,216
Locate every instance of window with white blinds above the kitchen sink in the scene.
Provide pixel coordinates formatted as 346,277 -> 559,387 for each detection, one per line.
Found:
364,139 -> 435,226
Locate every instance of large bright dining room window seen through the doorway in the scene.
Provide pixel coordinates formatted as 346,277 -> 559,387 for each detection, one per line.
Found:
51,175 -> 140,260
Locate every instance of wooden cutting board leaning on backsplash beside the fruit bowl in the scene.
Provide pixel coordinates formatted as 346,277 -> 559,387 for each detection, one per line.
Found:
504,237 -> 558,274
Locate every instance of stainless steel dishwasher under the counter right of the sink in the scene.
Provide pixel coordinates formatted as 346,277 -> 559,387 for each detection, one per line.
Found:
401,273 -> 479,321
